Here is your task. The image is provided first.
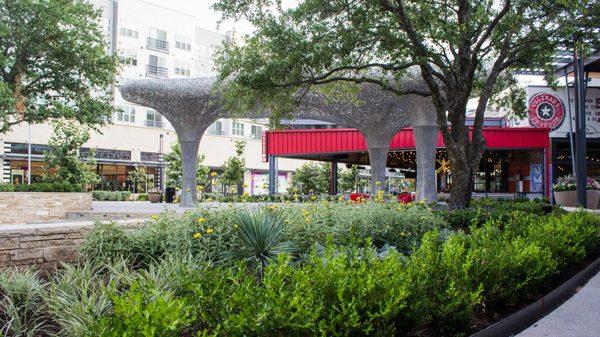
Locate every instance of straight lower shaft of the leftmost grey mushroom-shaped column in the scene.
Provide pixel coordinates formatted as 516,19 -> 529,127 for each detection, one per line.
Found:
179,140 -> 200,207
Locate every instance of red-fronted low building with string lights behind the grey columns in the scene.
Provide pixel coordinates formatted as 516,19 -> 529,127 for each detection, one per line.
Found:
264,127 -> 551,198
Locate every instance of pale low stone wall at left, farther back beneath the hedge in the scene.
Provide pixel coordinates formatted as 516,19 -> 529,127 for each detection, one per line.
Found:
0,192 -> 92,225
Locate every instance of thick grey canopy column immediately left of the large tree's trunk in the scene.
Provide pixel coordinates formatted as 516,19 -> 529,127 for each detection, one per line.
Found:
413,125 -> 438,201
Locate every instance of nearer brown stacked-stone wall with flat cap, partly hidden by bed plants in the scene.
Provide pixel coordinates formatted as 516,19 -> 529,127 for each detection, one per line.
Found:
0,220 -> 143,269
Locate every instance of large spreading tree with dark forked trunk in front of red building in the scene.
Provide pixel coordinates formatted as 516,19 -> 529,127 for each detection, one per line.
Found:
214,0 -> 600,208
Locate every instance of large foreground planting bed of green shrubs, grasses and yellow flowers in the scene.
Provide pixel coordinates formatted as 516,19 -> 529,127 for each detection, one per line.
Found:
0,198 -> 600,336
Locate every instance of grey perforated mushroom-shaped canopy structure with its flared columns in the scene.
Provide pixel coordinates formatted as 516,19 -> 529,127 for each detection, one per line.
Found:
120,77 -> 437,207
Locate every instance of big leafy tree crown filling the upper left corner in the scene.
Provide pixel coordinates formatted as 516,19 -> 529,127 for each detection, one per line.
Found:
0,0 -> 118,133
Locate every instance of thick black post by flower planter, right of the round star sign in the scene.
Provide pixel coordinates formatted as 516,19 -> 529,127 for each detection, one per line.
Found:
573,47 -> 587,207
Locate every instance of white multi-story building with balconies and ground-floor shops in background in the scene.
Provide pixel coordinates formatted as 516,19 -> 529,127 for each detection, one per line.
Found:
0,0 -> 302,194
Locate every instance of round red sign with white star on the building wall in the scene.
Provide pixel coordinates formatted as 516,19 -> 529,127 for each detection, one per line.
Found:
528,93 -> 565,130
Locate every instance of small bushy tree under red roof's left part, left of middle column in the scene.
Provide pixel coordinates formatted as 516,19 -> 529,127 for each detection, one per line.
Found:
290,162 -> 330,194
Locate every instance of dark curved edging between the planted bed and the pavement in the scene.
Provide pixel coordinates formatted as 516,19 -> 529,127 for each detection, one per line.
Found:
470,258 -> 600,337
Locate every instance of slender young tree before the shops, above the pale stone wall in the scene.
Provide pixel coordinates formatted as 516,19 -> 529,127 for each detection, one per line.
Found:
44,119 -> 98,186
